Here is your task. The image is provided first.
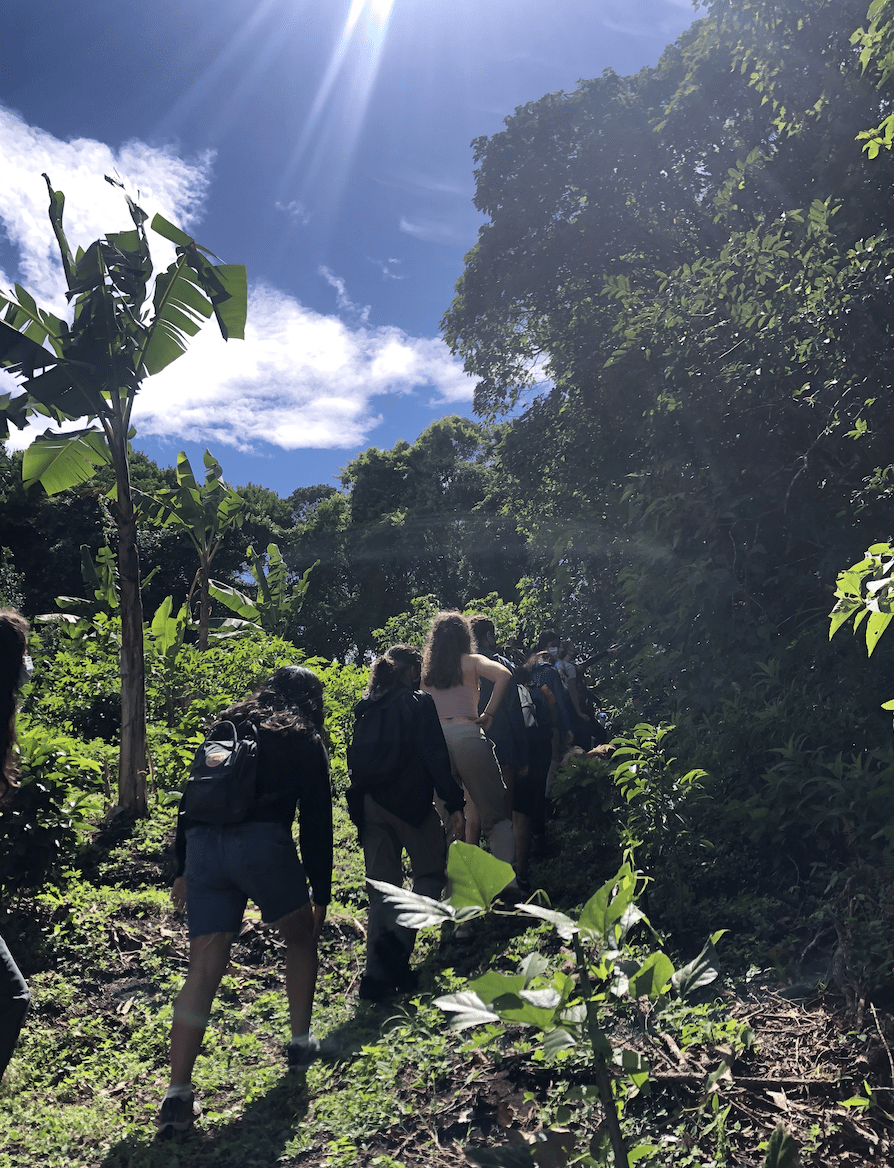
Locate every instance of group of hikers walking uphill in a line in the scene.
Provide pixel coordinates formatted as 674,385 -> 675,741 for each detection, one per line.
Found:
0,610 -> 610,1133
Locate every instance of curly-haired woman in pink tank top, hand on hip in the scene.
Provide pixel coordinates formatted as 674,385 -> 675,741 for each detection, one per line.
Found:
422,612 -> 515,864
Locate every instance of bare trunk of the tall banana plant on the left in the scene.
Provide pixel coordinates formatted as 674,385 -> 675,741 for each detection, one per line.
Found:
115,439 -> 148,815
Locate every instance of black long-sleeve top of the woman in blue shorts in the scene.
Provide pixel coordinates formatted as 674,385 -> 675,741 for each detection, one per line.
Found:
174,726 -> 332,905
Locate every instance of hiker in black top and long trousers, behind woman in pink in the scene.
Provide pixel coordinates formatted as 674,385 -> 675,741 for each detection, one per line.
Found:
347,645 -> 465,1002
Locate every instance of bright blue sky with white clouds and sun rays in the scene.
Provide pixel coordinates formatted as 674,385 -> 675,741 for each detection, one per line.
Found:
0,0 -> 698,495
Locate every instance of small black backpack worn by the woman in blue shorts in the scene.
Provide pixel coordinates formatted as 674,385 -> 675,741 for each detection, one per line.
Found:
181,722 -> 257,823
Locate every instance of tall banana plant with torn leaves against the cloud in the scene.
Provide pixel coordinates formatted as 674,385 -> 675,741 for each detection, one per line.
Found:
0,175 -> 248,815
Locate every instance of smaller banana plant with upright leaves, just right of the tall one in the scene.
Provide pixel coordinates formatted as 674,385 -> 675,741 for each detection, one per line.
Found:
143,450 -> 245,652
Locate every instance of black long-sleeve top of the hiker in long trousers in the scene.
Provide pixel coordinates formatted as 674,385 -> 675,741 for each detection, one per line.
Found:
348,686 -> 465,827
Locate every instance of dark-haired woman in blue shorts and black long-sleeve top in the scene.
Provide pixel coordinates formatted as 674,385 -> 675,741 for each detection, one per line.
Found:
158,665 -> 332,1134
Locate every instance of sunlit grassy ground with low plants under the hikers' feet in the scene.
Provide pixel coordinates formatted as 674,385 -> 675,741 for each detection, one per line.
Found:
0,805 -> 892,1168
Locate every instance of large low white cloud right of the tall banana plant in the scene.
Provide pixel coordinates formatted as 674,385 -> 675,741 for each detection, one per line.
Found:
127,286 -> 473,450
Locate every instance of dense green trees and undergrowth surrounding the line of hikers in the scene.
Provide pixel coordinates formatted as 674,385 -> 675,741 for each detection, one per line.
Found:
0,0 -> 894,1168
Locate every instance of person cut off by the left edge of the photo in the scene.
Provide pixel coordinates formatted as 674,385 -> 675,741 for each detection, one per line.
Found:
0,609 -> 32,1079
